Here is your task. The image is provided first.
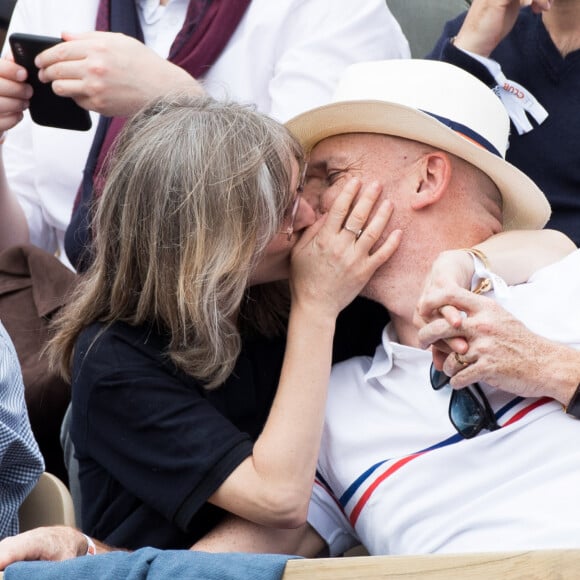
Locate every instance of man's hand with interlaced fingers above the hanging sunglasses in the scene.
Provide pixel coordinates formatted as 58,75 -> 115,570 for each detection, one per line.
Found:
418,289 -> 580,404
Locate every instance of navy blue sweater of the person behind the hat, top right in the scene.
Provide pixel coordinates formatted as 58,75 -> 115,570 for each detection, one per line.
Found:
427,7 -> 580,245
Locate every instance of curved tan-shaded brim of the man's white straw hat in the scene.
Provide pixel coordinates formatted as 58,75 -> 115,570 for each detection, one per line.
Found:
286,101 -> 551,230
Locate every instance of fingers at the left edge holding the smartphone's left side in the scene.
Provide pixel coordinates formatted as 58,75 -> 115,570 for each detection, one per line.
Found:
0,58 -> 32,132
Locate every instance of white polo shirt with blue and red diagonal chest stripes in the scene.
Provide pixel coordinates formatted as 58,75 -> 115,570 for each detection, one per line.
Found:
309,251 -> 580,554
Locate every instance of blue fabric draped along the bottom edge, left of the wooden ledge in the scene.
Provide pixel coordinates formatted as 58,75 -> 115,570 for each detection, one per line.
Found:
4,548 -> 296,580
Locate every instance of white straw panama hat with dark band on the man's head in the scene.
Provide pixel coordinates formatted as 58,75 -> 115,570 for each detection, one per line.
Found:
286,59 -> 550,230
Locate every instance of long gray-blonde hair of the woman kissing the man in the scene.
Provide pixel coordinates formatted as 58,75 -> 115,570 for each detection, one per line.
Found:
49,95 -> 302,388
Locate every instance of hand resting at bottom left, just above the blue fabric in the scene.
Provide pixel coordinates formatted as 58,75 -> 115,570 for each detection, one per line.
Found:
0,526 -> 87,570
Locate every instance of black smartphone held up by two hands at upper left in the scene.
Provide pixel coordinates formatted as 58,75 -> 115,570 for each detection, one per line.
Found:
9,32 -> 91,131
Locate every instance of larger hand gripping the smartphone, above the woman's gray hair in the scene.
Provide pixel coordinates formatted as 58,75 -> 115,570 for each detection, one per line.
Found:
35,32 -> 204,117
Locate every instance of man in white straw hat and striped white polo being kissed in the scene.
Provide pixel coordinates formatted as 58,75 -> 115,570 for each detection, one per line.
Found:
1,60 -> 580,559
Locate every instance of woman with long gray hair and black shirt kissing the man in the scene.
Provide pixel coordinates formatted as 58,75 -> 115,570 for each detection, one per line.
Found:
49,96 -> 400,548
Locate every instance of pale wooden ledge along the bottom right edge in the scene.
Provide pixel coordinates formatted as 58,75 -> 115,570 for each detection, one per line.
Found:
283,550 -> 580,580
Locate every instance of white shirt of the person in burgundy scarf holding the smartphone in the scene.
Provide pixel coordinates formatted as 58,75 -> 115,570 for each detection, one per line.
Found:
3,0 -> 410,268
